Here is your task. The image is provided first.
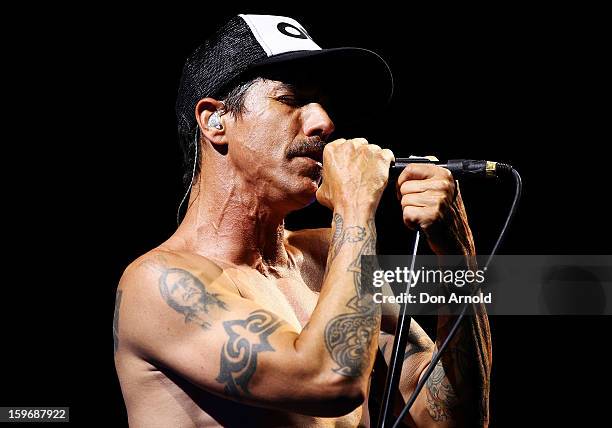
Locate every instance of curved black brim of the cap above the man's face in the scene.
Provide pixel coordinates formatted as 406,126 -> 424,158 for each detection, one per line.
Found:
251,47 -> 393,114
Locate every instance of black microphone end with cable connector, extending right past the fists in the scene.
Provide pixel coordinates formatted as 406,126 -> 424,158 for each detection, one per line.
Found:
390,156 -> 512,178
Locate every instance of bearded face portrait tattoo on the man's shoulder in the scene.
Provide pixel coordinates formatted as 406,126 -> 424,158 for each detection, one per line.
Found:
159,268 -> 228,330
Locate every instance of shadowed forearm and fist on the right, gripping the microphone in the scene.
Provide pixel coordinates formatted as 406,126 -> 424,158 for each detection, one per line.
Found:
397,164 -> 491,426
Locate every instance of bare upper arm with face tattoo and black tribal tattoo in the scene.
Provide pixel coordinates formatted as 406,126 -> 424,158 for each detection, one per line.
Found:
123,260 -> 344,413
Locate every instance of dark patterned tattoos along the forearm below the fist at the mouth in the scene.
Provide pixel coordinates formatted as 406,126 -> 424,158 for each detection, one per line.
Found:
325,214 -> 380,377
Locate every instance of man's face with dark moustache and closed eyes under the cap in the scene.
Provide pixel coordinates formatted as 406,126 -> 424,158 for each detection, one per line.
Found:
226,80 -> 334,210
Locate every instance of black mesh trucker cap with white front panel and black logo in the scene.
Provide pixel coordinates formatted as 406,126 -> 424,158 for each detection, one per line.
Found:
176,15 -> 393,136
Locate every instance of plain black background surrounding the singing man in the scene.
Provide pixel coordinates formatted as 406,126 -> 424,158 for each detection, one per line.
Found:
0,2 -> 611,427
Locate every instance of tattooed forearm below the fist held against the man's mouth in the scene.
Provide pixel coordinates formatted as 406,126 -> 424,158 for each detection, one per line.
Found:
296,209 -> 380,392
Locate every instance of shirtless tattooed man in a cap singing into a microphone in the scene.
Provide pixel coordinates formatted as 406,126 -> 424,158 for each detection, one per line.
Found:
114,16 -> 491,427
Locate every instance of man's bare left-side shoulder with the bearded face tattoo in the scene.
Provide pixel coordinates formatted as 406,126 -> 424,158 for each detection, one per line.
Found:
115,248 -> 238,356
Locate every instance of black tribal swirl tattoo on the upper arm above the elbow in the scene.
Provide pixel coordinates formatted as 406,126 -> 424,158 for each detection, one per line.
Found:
216,309 -> 282,397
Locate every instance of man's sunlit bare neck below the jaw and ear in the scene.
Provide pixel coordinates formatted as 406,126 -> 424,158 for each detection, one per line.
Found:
175,155 -> 289,273
